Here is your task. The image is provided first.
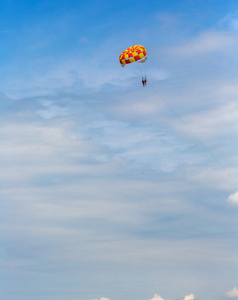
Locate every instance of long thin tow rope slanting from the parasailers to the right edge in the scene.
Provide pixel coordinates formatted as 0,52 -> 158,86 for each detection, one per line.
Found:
147,80 -> 238,186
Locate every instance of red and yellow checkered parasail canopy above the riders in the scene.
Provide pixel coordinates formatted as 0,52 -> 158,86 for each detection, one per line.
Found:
119,45 -> 147,67
